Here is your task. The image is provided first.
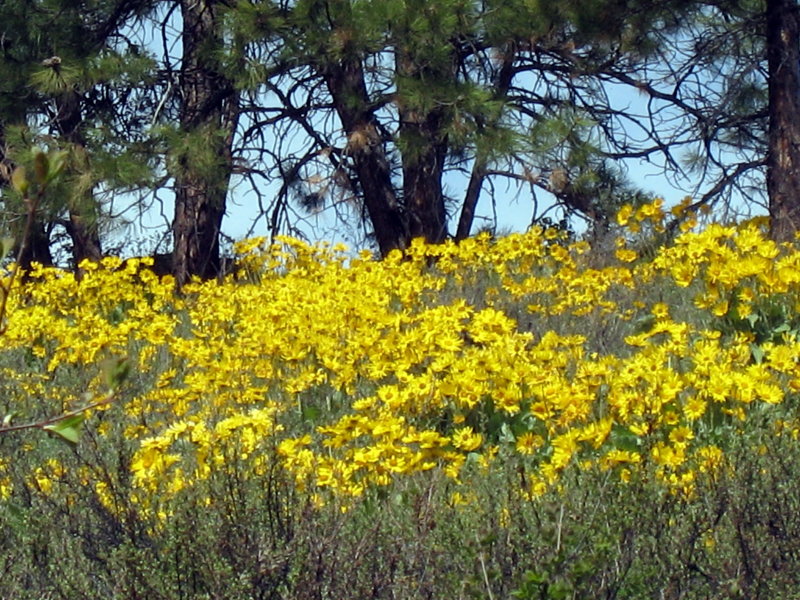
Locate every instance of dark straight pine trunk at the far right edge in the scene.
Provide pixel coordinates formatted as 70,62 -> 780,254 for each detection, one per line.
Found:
766,0 -> 800,242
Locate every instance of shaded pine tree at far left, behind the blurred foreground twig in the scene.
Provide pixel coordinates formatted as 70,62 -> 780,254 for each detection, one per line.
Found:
0,0 -> 161,266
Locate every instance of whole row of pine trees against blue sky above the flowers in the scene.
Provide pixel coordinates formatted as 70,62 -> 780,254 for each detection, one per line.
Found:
0,0 -> 800,282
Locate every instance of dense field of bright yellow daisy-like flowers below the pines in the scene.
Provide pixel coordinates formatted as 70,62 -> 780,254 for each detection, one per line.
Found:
0,201 -> 800,598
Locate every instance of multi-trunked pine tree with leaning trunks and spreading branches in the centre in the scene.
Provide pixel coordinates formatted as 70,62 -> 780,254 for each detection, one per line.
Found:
223,0 -> 700,254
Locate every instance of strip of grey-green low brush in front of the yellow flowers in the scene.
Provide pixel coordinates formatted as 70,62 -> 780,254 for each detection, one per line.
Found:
0,428 -> 800,599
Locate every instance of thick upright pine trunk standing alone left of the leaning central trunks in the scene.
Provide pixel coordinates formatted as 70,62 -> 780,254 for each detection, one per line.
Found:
172,0 -> 239,286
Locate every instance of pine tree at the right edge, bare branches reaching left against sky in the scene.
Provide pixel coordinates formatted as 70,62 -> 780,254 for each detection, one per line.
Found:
624,0 -> 800,241
